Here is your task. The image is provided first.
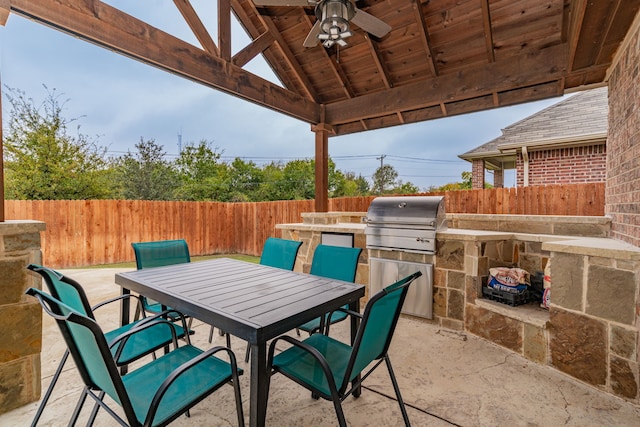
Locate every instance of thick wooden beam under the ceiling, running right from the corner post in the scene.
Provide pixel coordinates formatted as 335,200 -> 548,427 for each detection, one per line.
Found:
326,44 -> 567,125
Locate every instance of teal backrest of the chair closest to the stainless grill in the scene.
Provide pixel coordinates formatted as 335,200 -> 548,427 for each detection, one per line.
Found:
309,245 -> 362,282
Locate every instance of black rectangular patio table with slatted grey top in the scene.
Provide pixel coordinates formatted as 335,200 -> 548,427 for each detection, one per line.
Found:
115,258 -> 364,426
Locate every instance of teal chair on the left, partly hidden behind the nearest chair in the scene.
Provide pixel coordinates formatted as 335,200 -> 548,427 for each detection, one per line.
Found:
27,264 -> 188,427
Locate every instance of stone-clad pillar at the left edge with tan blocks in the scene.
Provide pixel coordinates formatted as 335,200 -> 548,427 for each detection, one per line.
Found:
0,221 -> 45,413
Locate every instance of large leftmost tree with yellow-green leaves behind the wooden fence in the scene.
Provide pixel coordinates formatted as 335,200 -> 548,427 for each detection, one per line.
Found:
4,86 -> 111,200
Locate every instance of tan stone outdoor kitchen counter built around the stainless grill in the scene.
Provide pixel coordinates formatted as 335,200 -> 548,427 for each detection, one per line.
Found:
276,212 -> 640,404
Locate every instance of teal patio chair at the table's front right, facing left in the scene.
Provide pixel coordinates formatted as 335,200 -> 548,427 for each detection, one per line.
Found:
267,271 -> 422,426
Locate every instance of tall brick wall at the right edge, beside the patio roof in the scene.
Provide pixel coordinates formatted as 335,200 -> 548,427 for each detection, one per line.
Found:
605,14 -> 640,246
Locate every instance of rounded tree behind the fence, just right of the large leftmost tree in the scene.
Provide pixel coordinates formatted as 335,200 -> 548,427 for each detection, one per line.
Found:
115,138 -> 179,200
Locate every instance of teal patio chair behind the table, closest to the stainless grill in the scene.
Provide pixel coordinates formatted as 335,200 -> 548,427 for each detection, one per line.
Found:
296,245 -> 362,336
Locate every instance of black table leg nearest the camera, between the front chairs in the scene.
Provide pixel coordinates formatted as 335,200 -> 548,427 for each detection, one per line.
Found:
249,343 -> 269,427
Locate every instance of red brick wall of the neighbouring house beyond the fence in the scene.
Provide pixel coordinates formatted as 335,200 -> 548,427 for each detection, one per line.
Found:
516,144 -> 606,187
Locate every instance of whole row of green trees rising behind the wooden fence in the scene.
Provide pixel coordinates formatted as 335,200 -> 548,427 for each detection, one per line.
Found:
4,85 -> 430,202
